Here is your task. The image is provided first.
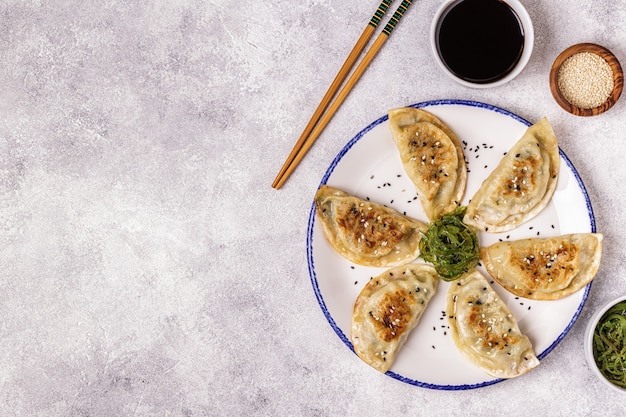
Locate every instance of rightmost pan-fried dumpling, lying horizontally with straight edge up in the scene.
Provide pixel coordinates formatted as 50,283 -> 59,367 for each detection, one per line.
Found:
481,233 -> 603,300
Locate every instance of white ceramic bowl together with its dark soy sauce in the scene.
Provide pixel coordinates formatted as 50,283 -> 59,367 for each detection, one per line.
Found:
431,0 -> 535,88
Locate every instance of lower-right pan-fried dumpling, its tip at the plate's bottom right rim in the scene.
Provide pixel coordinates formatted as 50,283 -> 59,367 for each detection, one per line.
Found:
446,269 -> 539,378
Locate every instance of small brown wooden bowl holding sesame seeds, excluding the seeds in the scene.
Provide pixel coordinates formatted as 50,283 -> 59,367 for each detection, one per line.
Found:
550,43 -> 624,116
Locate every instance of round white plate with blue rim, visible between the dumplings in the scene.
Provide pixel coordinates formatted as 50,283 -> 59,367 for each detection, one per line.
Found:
307,100 -> 596,390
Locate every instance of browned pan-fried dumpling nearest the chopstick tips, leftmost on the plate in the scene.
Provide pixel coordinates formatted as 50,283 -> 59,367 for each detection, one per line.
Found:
315,185 -> 427,267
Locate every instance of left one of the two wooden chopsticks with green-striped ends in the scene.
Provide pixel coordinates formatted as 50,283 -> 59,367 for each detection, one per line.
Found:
272,0 -> 393,189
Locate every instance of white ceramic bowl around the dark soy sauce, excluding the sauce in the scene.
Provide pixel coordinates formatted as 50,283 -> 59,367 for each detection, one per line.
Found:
430,0 -> 535,88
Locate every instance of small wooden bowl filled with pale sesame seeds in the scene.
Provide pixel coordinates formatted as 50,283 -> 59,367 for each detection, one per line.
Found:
550,43 -> 624,116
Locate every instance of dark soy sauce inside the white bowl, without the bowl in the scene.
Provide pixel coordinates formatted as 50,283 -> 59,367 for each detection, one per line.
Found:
437,0 -> 524,84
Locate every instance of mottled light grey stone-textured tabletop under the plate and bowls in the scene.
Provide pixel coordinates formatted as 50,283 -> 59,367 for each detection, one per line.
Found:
0,0 -> 626,416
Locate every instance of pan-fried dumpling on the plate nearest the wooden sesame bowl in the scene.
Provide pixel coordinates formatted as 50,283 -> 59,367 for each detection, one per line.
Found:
463,118 -> 559,232
